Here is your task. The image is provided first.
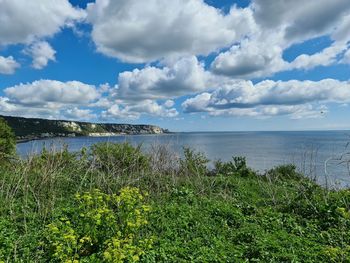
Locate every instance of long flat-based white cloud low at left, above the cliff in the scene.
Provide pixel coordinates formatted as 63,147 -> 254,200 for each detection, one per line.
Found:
4,80 -> 100,108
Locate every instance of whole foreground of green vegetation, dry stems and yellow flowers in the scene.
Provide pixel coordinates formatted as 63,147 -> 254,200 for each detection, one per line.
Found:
0,121 -> 350,262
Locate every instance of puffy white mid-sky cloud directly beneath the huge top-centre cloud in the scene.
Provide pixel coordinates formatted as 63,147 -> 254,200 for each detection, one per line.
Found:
115,56 -> 212,100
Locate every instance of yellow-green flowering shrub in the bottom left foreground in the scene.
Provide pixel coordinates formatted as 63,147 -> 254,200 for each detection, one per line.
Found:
46,187 -> 152,262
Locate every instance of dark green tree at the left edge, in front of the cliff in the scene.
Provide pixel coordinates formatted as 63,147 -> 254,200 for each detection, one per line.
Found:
0,118 -> 16,160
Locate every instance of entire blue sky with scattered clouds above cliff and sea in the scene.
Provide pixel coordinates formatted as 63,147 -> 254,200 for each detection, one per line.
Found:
0,0 -> 350,131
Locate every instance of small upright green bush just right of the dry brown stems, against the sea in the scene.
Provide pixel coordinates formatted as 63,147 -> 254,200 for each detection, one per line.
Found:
180,147 -> 209,176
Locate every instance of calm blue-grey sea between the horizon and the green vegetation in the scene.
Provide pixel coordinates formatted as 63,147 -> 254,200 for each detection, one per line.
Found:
17,131 -> 350,187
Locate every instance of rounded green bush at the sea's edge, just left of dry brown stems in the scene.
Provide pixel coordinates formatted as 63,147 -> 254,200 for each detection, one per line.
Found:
91,142 -> 150,174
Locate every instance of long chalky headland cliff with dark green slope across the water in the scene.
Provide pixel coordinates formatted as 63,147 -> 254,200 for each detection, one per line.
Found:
0,116 -> 169,140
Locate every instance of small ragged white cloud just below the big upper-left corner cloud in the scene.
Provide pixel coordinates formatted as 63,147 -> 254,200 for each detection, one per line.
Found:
24,41 -> 56,69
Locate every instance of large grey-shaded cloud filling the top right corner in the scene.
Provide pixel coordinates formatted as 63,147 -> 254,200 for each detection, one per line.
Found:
252,0 -> 350,41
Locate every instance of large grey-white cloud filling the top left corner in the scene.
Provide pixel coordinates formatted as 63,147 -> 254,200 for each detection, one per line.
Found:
0,0 -> 85,45
